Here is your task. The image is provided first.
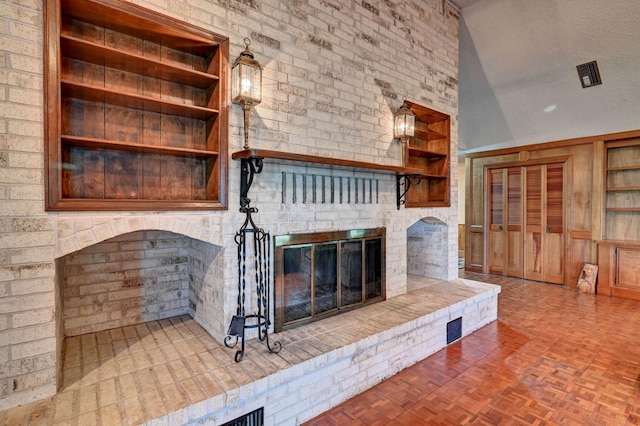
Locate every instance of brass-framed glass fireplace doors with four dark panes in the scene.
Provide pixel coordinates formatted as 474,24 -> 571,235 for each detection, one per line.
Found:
275,229 -> 385,331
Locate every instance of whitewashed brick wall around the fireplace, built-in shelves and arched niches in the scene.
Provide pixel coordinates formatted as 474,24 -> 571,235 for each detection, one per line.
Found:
0,0 -> 458,409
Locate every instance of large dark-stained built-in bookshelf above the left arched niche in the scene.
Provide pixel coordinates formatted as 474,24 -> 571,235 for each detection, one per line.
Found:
44,0 -> 229,211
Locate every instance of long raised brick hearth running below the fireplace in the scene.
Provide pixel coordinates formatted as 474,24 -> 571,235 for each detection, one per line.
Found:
0,276 -> 500,425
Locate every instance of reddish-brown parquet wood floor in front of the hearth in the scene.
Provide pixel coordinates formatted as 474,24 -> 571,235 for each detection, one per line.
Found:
305,271 -> 640,426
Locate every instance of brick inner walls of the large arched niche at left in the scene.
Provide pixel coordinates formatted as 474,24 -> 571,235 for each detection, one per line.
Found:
57,230 -> 225,340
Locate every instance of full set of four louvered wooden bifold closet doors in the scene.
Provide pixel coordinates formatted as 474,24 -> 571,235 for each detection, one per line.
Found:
487,163 -> 564,284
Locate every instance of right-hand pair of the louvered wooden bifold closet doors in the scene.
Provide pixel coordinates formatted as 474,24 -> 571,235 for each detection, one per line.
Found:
524,163 -> 564,284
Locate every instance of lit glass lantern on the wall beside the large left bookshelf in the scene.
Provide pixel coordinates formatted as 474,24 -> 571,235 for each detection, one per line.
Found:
231,41 -> 262,105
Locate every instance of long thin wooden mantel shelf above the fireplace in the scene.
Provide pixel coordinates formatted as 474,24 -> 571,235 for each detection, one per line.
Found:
231,149 -> 424,176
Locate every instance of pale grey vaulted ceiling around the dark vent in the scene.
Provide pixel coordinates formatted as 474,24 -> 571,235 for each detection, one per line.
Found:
453,0 -> 640,152
